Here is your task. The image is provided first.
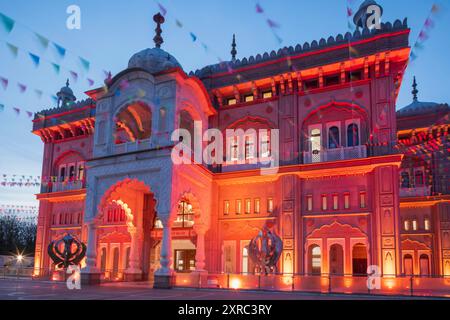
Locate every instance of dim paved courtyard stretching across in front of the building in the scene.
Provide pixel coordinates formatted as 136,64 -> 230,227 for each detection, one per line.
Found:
0,279 -> 446,301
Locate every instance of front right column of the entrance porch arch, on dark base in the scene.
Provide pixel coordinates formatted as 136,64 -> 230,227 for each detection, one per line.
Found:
154,214 -> 174,289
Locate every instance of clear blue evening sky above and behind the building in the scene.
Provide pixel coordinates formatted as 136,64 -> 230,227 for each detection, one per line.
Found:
0,0 -> 450,205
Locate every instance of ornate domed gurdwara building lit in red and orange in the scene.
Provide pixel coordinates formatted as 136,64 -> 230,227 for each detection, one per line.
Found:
33,2 -> 450,287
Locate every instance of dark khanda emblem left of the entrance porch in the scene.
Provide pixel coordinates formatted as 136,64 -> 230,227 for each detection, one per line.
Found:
47,234 -> 86,269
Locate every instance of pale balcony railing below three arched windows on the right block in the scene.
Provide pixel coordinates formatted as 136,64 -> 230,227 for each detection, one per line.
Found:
303,146 -> 367,164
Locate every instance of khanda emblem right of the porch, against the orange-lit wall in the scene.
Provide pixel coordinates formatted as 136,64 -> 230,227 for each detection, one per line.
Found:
248,226 -> 283,274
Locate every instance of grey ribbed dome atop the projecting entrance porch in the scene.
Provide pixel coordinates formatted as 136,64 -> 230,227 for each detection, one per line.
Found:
128,48 -> 181,74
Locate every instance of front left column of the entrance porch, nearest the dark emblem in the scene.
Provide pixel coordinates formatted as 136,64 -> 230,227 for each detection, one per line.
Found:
81,221 -> 100,284
